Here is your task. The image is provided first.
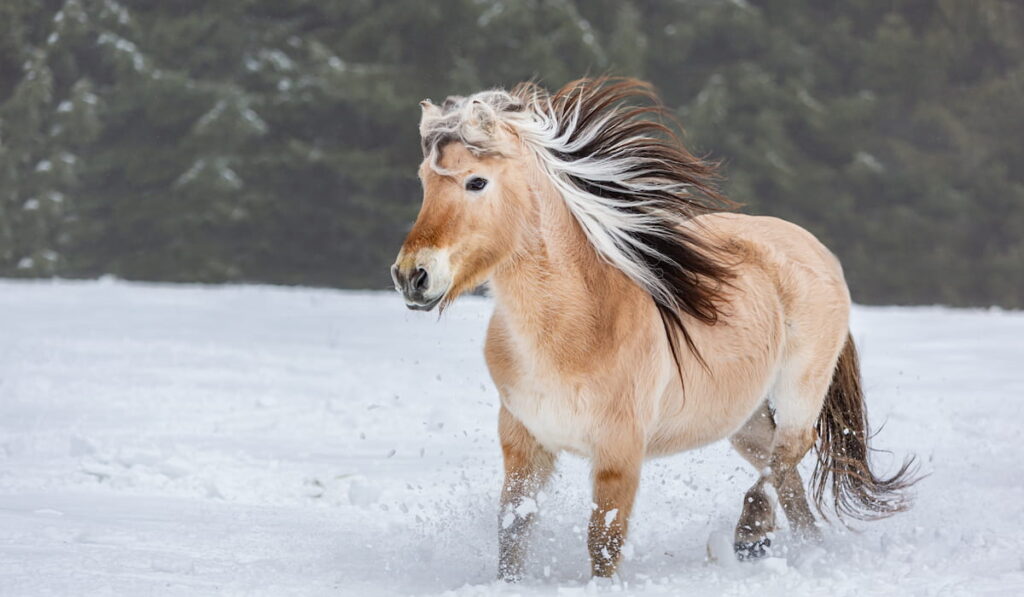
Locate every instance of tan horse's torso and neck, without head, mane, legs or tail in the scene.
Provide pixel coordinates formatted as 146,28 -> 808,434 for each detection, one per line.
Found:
485,191 -> 850,457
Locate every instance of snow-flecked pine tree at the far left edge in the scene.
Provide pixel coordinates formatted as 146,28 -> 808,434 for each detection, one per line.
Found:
0,0 -> 109,275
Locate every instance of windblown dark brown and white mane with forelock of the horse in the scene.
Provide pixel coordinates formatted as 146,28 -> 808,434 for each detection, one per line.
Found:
421,77 -> 734,363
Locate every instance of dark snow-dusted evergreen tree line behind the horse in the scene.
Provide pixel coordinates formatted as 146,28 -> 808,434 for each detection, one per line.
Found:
0,0 -> 1024,307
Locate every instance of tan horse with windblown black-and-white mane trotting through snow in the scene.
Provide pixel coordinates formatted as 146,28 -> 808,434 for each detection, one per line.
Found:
391,77 -> 916,581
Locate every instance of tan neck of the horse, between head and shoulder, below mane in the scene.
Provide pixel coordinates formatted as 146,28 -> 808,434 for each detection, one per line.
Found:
492,166 -> 653,364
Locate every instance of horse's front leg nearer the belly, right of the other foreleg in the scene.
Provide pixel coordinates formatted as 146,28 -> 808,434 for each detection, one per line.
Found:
587,436 -> 644,577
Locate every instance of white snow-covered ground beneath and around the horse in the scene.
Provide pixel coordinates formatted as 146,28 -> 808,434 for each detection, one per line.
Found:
0,281 -> 1024,597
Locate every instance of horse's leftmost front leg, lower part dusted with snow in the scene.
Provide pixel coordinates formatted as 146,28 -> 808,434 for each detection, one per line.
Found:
498,407 -> 555,582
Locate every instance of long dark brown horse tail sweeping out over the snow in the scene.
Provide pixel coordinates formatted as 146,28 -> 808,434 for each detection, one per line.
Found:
811,336 -> 918,520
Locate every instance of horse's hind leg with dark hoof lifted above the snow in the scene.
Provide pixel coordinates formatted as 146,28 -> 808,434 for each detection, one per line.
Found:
730,401 -> 775,560
